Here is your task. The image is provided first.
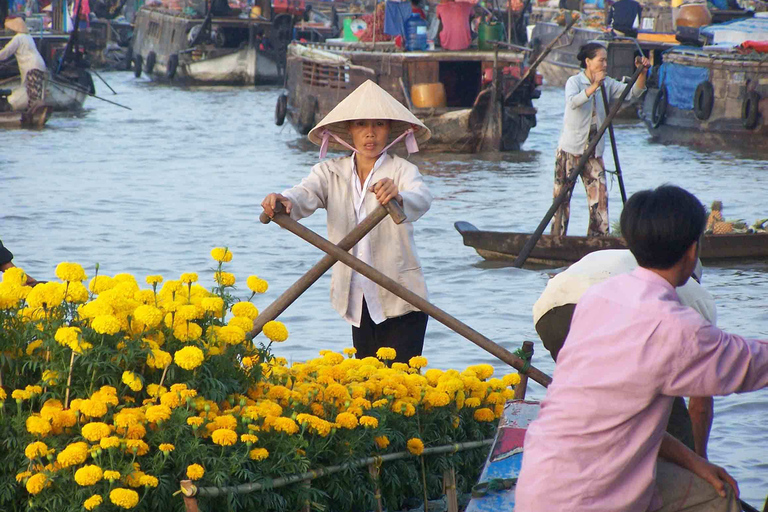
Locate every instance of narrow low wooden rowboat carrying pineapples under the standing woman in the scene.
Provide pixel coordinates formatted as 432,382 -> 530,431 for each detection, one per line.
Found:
454,221 -> 768,267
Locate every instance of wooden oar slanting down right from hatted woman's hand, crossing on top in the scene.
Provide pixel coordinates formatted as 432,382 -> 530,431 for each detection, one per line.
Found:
264,204 -> 552,387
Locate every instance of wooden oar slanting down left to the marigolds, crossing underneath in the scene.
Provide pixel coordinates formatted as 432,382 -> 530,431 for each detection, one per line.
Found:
248,201 -> 405,339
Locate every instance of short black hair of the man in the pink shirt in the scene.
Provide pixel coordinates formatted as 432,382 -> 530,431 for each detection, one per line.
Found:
621,185 -> 707,270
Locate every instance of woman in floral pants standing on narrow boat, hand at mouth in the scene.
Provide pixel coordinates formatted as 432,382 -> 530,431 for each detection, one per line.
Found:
551,43 -> 650,236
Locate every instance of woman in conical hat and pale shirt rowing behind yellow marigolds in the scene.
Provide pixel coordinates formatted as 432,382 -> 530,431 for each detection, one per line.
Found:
261,80 -> 432,362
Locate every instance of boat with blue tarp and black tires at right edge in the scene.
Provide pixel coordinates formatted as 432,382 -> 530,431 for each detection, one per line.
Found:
642,17 -> 768,149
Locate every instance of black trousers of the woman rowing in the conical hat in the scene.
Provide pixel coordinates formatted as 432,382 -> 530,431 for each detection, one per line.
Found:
352,299 -> 429,363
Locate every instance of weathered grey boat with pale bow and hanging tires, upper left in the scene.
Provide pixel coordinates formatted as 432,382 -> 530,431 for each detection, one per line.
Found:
131,2 -> 293,85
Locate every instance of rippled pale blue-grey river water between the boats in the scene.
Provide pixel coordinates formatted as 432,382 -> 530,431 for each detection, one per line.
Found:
0,72 -> 768,508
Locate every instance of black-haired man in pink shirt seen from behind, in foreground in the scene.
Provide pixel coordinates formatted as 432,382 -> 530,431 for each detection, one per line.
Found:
515,185 -> 768,512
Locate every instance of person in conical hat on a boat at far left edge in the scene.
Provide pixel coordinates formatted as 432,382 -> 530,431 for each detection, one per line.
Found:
0,18 -> 46,109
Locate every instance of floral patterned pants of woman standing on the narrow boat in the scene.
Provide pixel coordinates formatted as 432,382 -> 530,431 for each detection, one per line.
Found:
551,149 -> 610,236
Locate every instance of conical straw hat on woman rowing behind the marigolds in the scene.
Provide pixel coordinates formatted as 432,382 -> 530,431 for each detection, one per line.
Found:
309,80 -> 432,150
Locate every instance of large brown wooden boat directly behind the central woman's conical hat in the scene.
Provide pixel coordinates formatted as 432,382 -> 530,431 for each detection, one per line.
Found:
275,42 -> 540,153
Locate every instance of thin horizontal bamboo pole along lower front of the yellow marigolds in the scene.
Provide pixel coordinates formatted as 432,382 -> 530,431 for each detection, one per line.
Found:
187,439 -> 494,498
